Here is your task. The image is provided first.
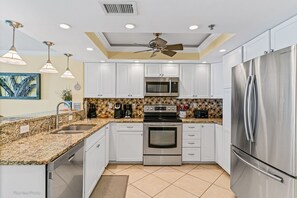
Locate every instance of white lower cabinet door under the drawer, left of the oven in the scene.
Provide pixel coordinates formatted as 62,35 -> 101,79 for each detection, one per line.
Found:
117,132 -> 143,162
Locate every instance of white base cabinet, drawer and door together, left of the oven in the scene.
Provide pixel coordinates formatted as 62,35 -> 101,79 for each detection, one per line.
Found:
116,123 -> 143,162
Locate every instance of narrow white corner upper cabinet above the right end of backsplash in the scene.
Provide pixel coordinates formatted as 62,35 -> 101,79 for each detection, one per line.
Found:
211,63 -> 224,98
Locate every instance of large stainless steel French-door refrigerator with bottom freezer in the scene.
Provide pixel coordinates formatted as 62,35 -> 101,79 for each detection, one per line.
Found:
231,46 -> 297,198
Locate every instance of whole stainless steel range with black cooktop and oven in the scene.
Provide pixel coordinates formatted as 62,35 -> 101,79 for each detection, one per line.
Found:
143,105 -> 182,165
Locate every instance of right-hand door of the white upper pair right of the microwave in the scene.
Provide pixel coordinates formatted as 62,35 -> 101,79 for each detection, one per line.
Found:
193,64 -> 210,98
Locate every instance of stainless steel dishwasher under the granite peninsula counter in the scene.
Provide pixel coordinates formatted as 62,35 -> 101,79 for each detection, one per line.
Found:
47,142 -> 84,198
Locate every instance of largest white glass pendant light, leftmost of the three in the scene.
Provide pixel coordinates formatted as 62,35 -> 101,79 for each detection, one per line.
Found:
0,20 -> 27,65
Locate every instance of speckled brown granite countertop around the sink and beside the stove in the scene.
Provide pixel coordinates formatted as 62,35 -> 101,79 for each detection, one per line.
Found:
0,118 -> 222,165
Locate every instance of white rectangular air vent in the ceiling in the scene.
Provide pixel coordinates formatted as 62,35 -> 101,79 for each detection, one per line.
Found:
100,2 -> 137,15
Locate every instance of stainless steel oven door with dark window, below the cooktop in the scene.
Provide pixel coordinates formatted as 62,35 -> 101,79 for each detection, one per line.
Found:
143,123 -> 182,155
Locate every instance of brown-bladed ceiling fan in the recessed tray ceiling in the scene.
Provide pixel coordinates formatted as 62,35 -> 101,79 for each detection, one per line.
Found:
134,33 -> 184,58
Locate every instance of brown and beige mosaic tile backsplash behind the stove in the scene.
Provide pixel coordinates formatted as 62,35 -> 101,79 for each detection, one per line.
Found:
85,97 -> 223,118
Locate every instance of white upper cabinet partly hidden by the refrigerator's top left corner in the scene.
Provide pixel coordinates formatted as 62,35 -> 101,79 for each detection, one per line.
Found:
223,47 -> 242,88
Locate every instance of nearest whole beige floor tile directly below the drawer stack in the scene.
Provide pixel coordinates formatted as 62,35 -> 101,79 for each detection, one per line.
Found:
173,175 -> 211,197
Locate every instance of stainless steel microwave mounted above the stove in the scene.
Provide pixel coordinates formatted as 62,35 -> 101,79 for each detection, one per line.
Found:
144,77 -> 179,96
